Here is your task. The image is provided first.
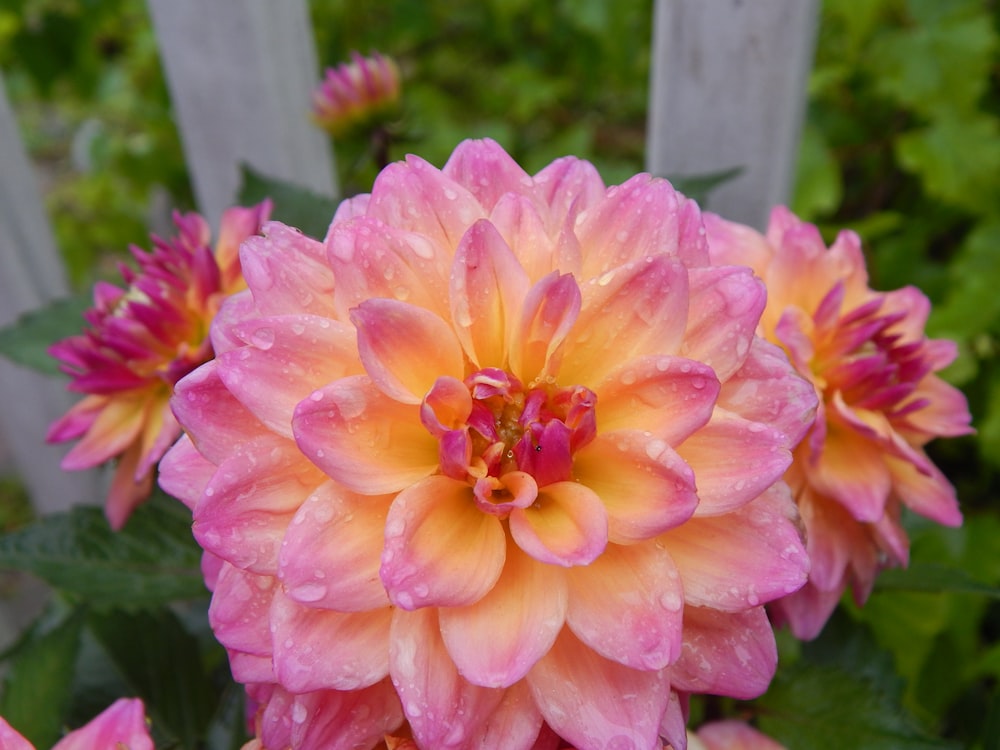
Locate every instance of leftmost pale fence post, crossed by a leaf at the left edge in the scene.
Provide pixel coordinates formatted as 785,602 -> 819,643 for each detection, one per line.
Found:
0,72 -> 104,513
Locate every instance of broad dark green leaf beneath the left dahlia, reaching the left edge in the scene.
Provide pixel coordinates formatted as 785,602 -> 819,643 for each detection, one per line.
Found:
0,497 -> 205,608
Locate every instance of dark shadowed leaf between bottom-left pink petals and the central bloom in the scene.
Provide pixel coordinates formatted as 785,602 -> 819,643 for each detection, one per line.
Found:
87,609 -> 218,748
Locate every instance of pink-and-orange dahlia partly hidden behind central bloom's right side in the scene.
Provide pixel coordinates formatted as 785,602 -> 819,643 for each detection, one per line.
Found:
706,207 -> 971,638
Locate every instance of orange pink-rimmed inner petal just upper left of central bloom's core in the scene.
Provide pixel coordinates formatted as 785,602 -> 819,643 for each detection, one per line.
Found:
351,299 -> 465,404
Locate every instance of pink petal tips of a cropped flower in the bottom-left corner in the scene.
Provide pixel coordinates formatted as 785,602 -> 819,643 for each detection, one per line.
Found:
0,698 -> 153,750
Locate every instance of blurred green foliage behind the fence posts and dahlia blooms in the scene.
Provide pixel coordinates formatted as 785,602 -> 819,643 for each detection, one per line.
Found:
0,0 -> 1000,750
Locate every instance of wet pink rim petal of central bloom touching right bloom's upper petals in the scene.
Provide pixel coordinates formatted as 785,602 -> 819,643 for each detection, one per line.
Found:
680,266 -> 767,383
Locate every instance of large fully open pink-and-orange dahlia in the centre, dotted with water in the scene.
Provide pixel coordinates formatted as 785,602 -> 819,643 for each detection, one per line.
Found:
160,141 -> 815,750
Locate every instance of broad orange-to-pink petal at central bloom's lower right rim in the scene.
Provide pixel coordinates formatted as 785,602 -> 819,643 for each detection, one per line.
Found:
660,483 -> 809,611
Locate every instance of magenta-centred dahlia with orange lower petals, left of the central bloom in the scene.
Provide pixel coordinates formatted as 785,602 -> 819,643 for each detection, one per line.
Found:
47,201 -> 271,529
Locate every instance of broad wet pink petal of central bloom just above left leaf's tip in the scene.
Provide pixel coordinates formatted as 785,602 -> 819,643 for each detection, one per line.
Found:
192,434 -> 323,574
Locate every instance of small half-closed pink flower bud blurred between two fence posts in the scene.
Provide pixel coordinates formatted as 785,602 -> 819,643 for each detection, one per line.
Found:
312,52 -> 401,135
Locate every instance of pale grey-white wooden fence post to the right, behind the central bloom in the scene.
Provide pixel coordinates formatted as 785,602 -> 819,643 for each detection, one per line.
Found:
646,0 -> 818,228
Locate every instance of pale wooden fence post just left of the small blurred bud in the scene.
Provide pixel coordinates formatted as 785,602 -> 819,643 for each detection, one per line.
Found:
149,0 -> 336,223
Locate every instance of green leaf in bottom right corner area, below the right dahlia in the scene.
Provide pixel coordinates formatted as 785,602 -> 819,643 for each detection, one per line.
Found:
759,616 -> 957,750
